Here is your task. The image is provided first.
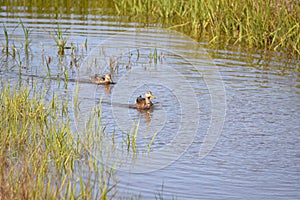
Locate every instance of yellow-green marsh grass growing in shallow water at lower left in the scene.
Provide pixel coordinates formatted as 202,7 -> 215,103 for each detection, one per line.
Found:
0,84 -> 117,199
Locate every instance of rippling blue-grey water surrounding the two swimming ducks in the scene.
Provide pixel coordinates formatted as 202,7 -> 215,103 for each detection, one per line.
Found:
0,2 -> 300,199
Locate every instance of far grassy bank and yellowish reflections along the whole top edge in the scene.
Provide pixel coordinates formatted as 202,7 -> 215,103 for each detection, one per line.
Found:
4,0 -> 300,56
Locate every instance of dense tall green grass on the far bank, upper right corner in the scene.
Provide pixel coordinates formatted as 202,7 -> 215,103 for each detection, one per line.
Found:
115,0 -> 300,55
